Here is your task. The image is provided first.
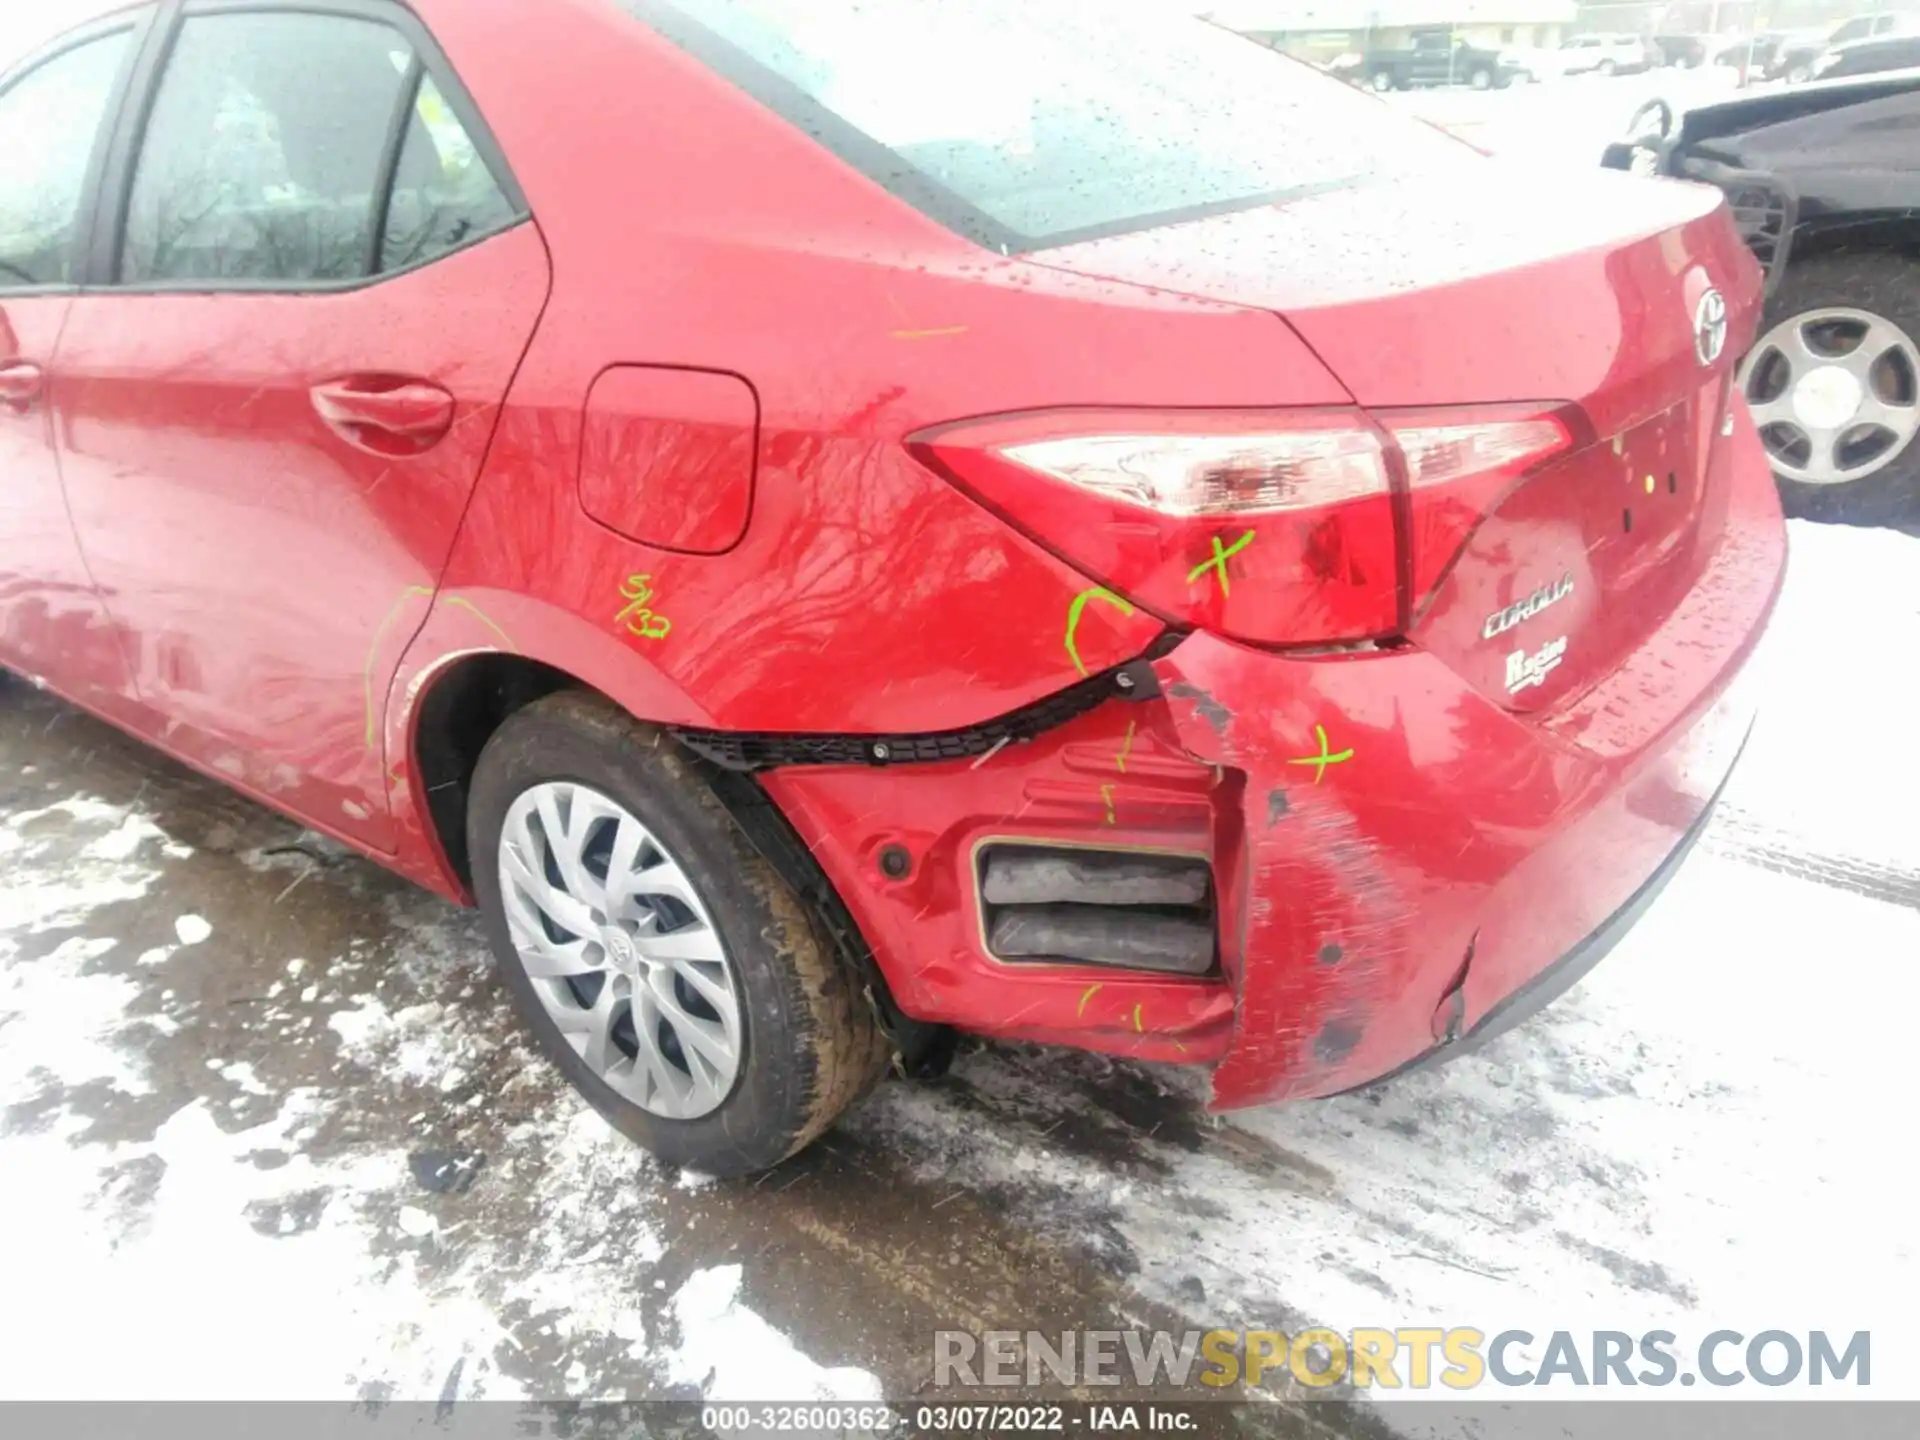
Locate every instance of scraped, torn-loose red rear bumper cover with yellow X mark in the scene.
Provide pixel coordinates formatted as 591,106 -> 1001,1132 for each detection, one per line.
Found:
1156,410 -> 1786,1108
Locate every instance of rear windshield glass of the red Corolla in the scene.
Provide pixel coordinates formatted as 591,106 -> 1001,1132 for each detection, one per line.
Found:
622,0 -> 1476,252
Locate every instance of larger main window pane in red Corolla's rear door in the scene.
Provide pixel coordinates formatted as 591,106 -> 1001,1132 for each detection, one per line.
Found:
121,12 -> 413,284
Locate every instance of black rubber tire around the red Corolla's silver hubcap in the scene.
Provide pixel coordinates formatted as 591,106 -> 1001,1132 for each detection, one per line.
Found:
467,691 -> 887,1177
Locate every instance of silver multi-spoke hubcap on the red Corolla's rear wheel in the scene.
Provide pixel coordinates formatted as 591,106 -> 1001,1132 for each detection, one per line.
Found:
499,781 -> 741,1119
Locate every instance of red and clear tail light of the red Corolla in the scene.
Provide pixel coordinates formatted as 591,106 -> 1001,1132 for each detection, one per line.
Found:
910,407 -> 1571,645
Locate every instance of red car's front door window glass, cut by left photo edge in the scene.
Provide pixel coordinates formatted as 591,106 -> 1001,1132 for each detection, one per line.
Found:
0,31 -> 132,290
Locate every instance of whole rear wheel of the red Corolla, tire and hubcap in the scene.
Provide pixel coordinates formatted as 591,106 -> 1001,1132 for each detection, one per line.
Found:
468,693 -> 885,1175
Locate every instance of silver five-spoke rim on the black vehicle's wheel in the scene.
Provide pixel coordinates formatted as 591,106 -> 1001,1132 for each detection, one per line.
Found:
1740,305 -> 1920,486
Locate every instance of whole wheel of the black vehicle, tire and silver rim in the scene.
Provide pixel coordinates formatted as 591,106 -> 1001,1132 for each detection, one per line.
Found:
1740,253 -> 1920,524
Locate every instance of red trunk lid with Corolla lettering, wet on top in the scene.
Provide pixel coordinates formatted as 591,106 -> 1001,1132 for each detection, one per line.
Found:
1031,159 -> 1761,710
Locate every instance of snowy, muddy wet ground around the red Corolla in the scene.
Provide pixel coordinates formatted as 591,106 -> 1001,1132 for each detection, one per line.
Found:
0,524 -> 1920,1400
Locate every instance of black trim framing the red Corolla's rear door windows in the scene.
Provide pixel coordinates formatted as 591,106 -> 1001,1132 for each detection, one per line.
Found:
81,0 -> 532,294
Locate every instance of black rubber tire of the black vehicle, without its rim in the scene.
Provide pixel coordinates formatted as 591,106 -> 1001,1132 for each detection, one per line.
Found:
1743,252 -> 1920,524
